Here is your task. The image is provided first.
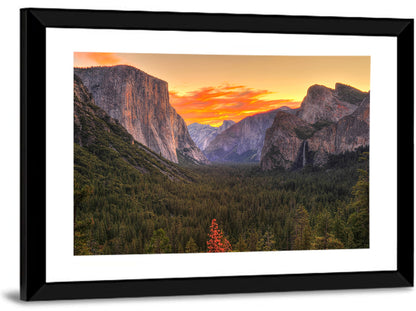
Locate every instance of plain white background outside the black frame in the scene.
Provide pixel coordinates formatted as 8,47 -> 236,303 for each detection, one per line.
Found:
0,0 -> 416,311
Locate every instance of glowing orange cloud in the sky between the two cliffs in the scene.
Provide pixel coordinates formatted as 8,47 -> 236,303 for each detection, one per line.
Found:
169,85 -> 300,126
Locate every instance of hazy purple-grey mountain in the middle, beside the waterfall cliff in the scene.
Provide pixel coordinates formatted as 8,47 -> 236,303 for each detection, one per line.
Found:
204,107 -> 293,162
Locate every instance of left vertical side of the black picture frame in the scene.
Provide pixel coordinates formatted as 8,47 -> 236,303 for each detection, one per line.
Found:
20,9 -> 46,300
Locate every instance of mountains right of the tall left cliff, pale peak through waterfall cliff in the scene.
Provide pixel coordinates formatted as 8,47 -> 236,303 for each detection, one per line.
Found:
188,83 -> 369,170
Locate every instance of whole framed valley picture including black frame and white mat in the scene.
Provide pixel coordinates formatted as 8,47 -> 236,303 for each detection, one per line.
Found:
21,9 -> 414,300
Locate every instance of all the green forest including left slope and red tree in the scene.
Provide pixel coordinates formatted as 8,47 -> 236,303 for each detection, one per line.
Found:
74,76 -> 369,255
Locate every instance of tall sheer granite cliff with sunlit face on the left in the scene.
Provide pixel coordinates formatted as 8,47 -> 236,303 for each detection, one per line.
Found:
74,65 -> 208,163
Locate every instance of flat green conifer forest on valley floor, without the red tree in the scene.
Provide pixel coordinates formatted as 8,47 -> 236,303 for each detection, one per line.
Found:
74,150 -> 369,255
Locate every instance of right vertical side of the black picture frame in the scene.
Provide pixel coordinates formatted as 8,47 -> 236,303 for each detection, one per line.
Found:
397,19 -> 414,286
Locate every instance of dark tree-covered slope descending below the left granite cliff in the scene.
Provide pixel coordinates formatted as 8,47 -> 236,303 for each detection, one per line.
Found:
74,75 -> 191,182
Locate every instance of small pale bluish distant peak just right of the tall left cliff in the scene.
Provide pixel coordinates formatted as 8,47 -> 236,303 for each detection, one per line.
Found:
188,120 -> 235,151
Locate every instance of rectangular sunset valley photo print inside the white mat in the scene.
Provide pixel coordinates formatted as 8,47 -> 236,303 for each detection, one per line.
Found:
73,52 -> 371,255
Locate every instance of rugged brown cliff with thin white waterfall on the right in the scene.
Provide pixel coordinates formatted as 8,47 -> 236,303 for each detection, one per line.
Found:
261,83 -> 370,170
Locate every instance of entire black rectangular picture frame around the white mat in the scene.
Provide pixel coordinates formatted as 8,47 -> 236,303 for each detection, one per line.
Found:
20,8 -> 414,300
